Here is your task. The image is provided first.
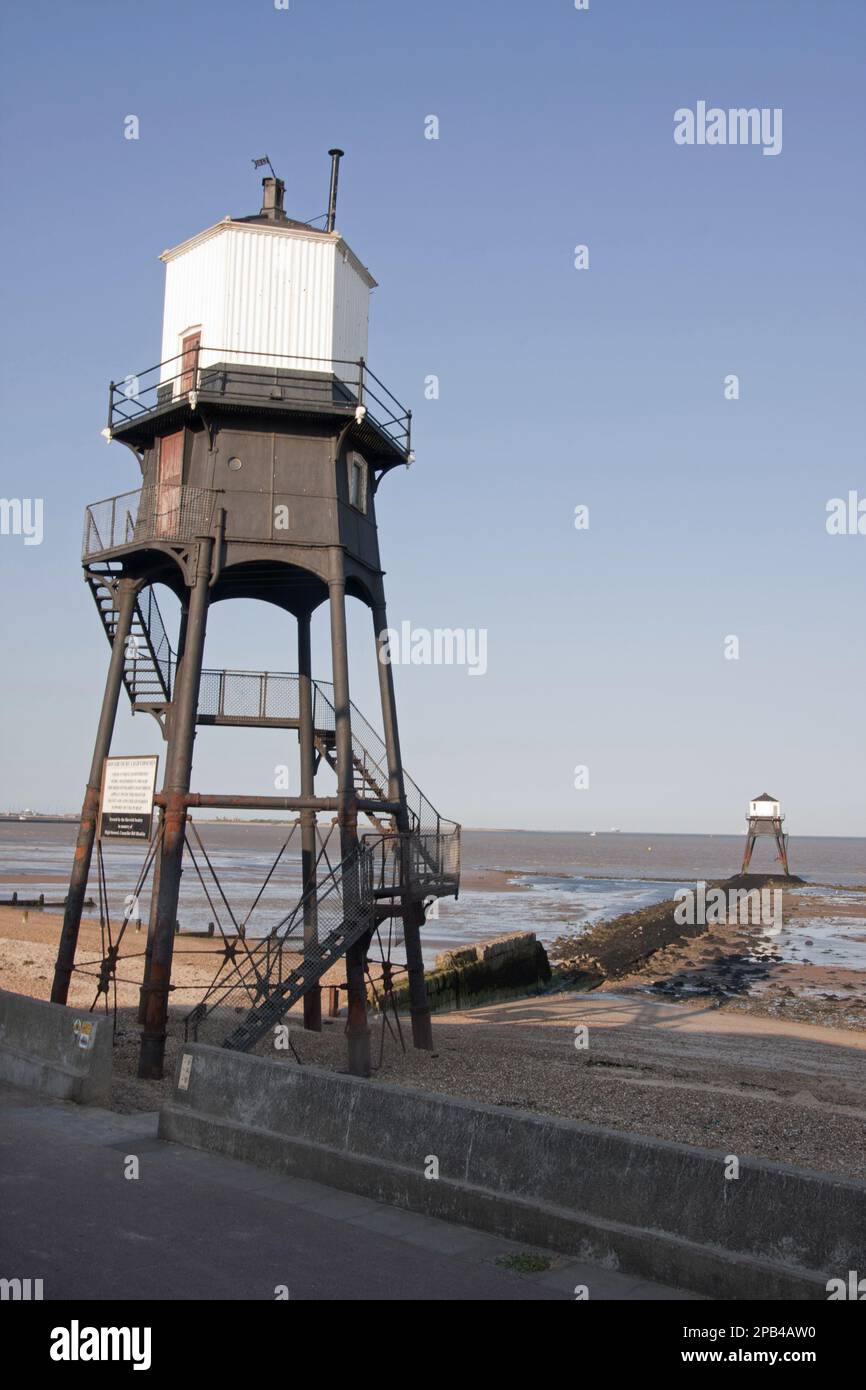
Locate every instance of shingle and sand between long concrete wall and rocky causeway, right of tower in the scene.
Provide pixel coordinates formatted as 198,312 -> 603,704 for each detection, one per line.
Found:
250,991 -> 866,1177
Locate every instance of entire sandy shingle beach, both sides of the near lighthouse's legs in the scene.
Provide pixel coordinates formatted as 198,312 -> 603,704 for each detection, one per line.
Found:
0,870 -> 866,1177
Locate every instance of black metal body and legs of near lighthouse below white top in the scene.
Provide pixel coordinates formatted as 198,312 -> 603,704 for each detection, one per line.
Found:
51,176 -> 459,1077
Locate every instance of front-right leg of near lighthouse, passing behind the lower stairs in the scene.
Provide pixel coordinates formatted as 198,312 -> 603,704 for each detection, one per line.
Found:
328,569 -> 373,1076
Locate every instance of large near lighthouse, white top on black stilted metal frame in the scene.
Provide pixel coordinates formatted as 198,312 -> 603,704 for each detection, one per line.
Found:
51,150 -> 460,1077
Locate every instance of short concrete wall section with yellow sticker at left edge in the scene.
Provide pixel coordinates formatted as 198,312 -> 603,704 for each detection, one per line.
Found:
0,990 -> 113,1105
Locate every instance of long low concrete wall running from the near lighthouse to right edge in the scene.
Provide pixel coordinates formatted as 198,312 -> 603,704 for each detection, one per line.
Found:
160,1045 -> 866,1298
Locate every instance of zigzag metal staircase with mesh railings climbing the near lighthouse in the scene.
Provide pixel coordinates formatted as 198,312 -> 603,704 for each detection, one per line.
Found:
85,578 -> 460,1051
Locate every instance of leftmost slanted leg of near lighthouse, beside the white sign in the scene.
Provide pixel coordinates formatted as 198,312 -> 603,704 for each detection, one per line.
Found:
51,578 -> 138,1004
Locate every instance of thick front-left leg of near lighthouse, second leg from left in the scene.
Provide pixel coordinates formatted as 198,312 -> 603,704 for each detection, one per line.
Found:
139,537 -> 214,1080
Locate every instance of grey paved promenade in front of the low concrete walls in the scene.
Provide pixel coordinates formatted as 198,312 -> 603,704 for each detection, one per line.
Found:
0,1086 -> 689,1301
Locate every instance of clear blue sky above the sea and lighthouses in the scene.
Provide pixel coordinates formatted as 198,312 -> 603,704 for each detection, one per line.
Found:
0,0 -> 866,835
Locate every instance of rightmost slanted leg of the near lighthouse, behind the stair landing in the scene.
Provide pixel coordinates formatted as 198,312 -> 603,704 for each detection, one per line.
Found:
373,603 -> 434,1052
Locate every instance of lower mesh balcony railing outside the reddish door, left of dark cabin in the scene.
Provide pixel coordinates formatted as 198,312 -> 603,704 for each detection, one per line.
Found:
82,484 -> 215,560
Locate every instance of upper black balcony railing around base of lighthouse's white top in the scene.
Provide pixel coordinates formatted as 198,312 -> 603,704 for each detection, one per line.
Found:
108,345 -> 411,455
